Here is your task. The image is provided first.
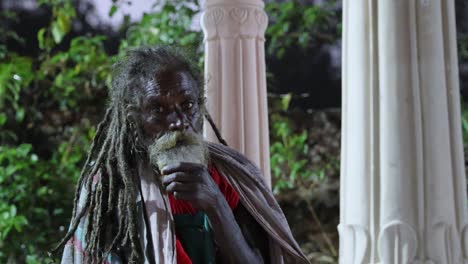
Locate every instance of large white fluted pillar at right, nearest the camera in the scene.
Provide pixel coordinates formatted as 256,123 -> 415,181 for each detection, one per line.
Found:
338,0 -> 468,264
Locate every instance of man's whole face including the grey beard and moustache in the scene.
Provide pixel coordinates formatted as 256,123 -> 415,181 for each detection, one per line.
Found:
135,69 -> 207,170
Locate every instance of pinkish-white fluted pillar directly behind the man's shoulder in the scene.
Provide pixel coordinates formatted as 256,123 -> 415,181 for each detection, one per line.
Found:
201,0 -> 270,185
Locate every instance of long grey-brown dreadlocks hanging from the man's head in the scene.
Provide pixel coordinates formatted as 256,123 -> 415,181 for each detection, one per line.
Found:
53,47 -> 229,263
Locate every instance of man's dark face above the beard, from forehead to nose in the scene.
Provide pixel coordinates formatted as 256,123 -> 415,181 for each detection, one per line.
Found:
135,69 -> 202,142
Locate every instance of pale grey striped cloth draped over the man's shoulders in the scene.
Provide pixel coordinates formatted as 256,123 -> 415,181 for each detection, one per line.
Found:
62,142 -> 309,264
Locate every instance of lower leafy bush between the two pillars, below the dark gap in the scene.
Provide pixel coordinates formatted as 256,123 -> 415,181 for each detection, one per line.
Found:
269,94 -> 340,263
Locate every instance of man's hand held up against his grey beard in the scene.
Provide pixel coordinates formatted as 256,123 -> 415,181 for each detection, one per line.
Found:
161,162 -> 223,212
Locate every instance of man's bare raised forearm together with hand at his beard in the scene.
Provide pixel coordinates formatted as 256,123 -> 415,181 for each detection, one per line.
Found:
162,163 -> 263,263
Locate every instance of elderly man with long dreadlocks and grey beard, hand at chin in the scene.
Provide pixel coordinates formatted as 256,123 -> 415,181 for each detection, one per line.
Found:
54,48 -> 308,264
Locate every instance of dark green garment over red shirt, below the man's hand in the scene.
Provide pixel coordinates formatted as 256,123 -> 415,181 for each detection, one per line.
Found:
174,211 -> 216,264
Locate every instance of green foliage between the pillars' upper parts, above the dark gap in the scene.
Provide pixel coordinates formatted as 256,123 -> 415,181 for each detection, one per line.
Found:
265,0 -> 341,58
